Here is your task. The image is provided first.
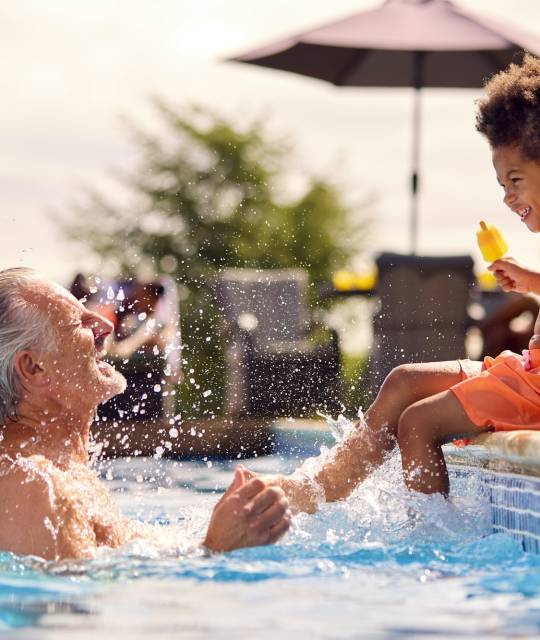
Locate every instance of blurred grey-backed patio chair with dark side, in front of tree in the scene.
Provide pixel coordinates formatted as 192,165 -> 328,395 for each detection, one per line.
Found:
214,269 -> 341,417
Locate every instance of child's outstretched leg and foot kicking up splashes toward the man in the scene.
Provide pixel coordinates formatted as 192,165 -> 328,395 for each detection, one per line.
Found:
270,361 -> 480,513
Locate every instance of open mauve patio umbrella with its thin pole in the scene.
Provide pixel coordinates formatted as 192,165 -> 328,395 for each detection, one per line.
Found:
233,0 -> 540,253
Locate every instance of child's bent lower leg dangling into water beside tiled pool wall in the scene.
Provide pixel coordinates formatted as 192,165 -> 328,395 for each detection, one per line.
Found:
398,391 -> 490,495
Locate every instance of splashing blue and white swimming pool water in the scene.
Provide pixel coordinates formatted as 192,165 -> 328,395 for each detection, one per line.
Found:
0,455 -> 540,640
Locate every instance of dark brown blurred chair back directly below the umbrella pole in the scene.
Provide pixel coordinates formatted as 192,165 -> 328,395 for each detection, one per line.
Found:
368,253 -> 475,391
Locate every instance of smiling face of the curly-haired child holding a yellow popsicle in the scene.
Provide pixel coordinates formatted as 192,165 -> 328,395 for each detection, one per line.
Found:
492,145 -> 540,233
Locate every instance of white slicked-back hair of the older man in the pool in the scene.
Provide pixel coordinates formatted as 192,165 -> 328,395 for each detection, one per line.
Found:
0,268 -> 56,425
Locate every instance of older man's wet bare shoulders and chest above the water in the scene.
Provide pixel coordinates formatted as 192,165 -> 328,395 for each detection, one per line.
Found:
0,455 -> 125,559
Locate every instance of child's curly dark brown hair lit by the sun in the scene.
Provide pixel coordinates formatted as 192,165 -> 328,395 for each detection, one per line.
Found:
476,54 -> 540,163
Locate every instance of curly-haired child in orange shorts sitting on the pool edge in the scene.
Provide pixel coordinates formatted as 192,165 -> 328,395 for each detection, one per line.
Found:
247,55 -> 540,512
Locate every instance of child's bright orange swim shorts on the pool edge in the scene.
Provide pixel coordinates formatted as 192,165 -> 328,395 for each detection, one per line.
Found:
451,349 -> 540,431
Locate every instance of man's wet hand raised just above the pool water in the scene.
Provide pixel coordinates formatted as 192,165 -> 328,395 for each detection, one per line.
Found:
204,467 -> 291,551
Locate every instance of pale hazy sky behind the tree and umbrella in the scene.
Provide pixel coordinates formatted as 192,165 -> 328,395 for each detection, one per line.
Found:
0,0 -> 540,283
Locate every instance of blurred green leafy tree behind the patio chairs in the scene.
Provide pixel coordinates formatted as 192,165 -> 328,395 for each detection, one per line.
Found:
63,103 -> 365,413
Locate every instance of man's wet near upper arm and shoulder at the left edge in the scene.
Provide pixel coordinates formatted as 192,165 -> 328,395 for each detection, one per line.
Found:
0,455 -> 57,559
